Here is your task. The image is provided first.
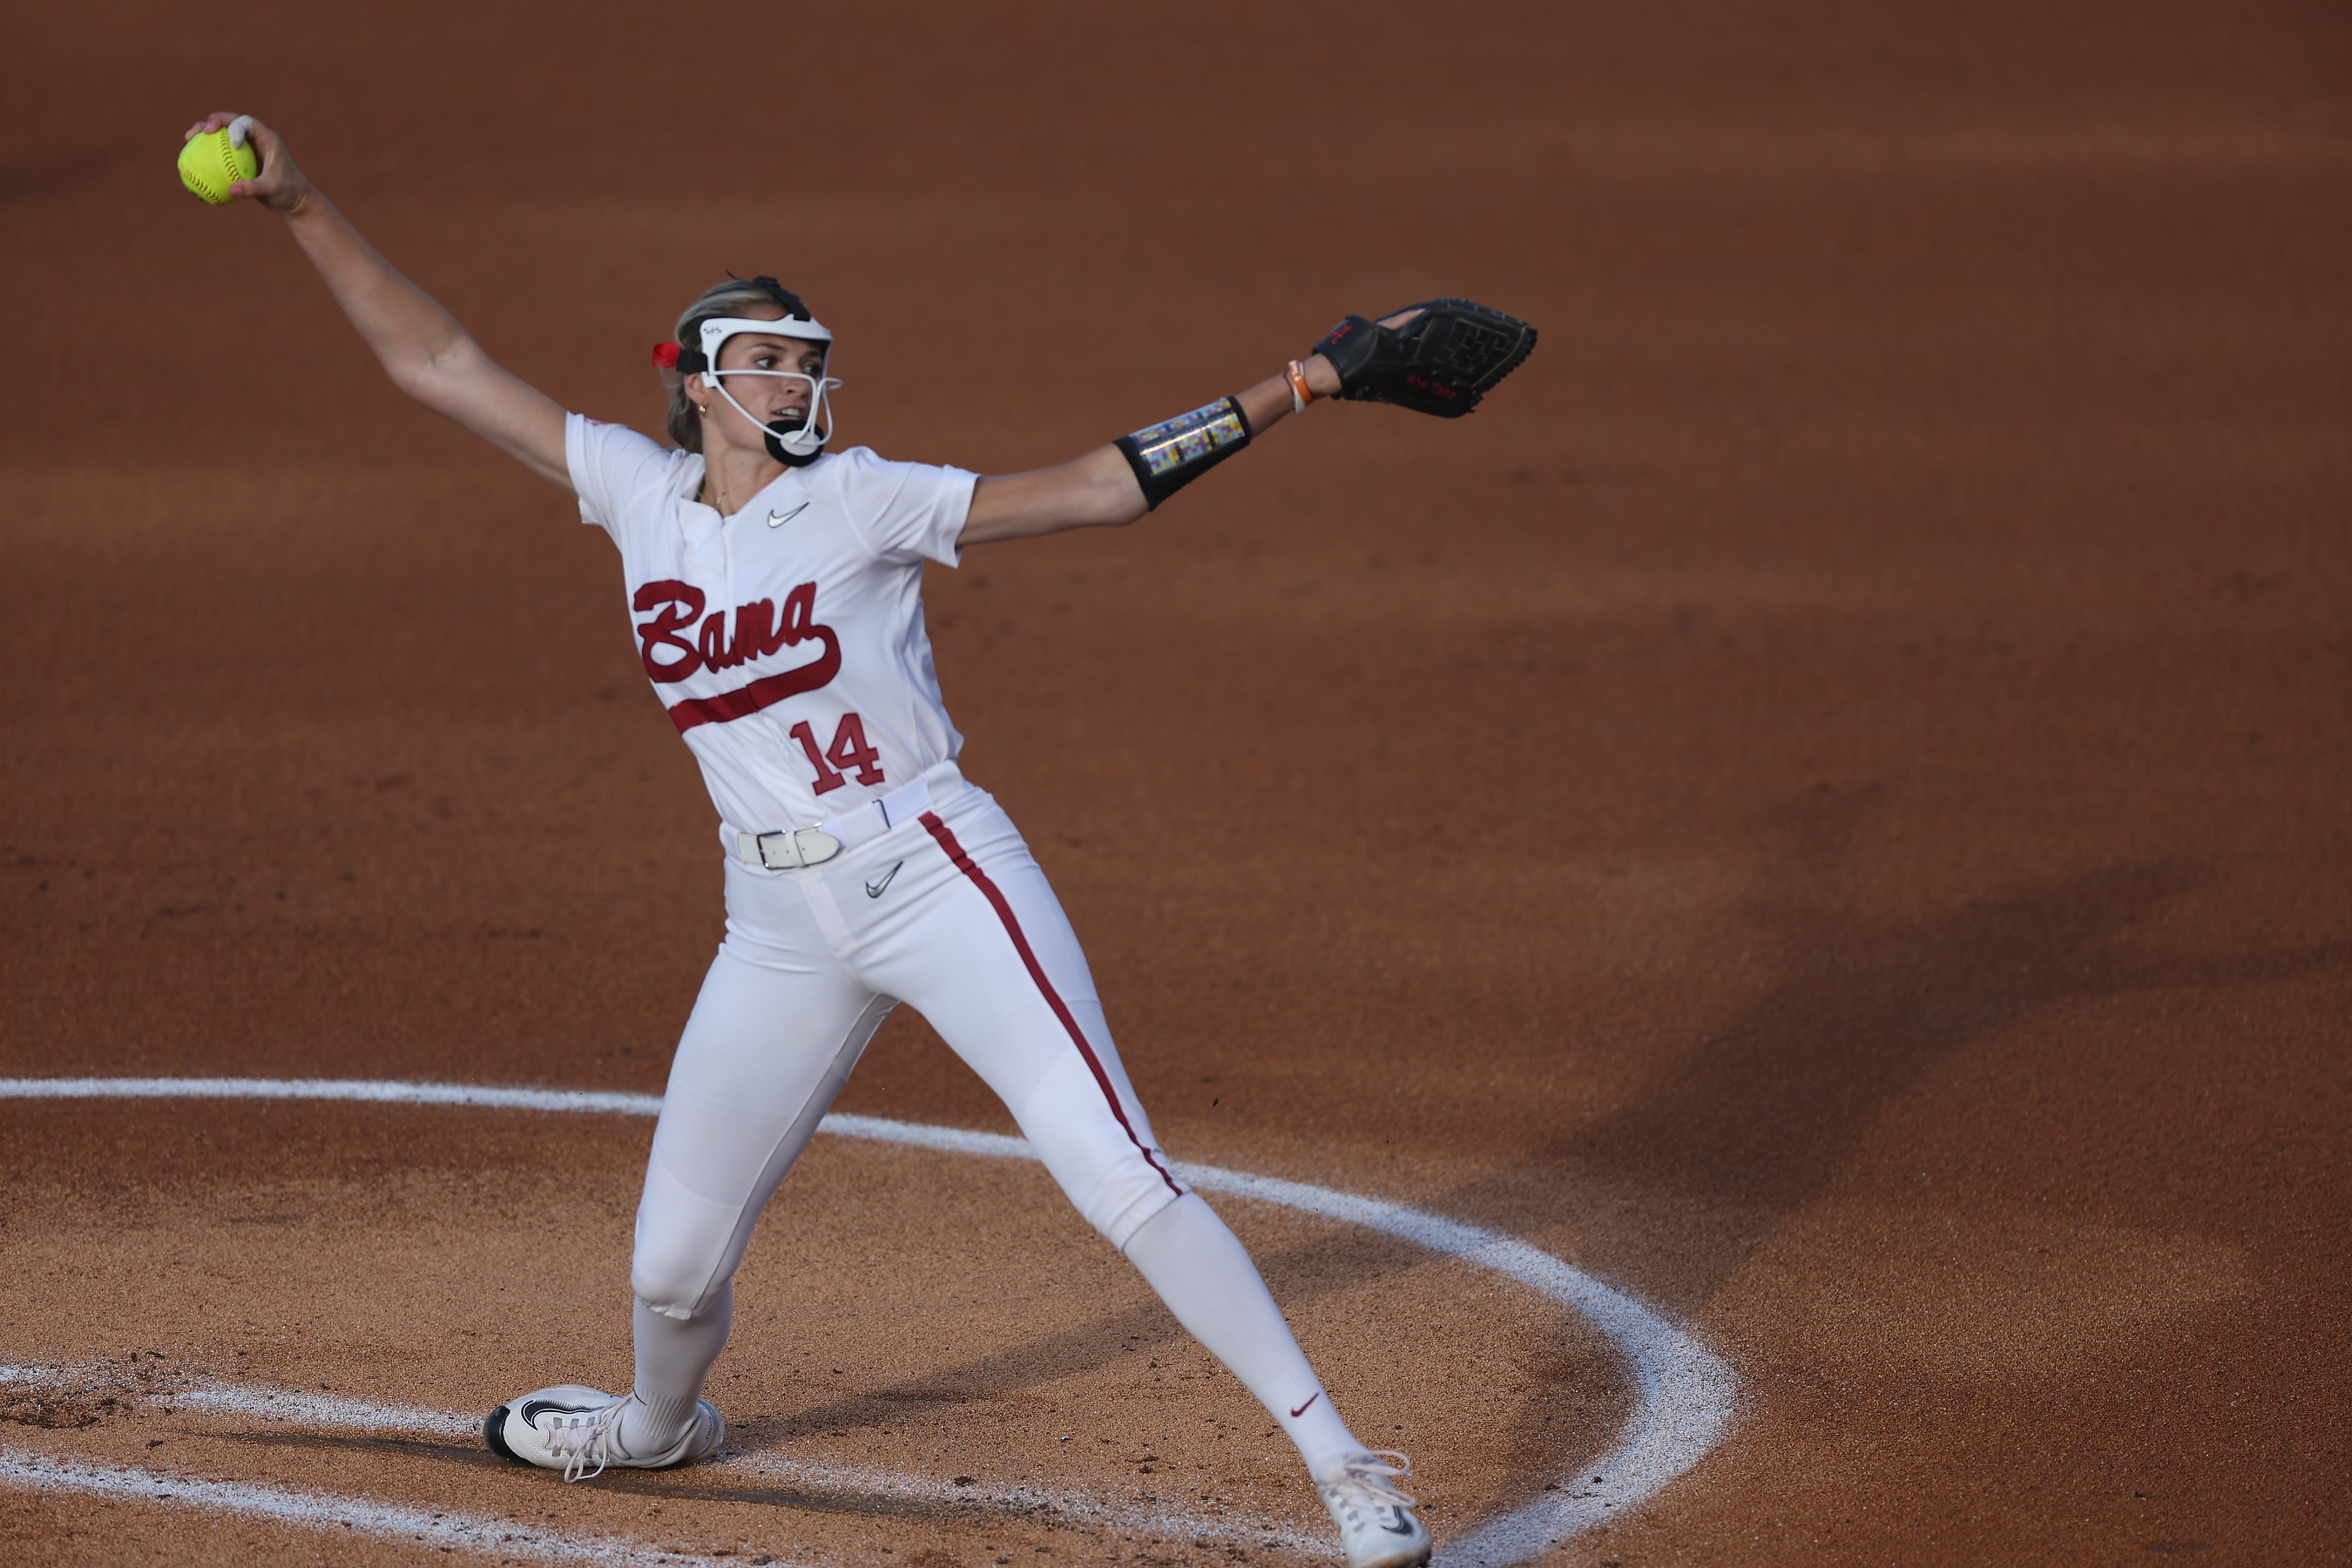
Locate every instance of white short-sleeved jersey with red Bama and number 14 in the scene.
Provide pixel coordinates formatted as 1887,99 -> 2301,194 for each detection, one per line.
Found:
564,414 -> 978,847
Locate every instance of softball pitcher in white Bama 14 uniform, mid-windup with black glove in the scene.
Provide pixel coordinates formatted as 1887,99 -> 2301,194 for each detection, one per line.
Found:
188,113 -> 1533,1568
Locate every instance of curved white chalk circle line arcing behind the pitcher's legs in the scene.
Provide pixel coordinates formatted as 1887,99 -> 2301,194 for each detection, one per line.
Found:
0,1079 -> 1738,1568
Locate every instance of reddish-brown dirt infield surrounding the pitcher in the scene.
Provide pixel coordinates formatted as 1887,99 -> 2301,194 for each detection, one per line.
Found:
0,4 -> 2352,1568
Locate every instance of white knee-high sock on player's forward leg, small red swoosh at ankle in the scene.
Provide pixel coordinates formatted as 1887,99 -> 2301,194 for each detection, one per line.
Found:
1119,1192 -> 1362,1474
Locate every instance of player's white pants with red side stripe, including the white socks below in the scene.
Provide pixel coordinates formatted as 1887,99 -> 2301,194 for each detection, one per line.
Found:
624,768 -> 1357,1467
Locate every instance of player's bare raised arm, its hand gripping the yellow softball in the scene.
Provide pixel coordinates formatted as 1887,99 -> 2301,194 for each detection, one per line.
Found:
188,113 -> 571,489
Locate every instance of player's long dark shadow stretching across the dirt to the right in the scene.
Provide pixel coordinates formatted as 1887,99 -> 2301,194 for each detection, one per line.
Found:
743,787 -> 2352,1486
